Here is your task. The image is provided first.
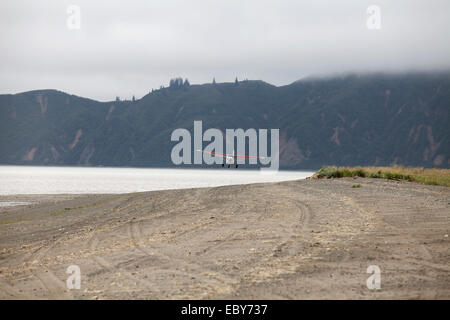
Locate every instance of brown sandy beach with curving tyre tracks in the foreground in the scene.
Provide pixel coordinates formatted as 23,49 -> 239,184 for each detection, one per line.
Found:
0,178 -> 450,299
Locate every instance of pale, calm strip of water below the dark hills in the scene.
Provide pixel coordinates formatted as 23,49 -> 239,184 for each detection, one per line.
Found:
0,166 -> 313,195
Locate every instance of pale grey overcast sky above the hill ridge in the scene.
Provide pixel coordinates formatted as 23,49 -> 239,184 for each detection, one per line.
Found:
0,0 -> 450,101
